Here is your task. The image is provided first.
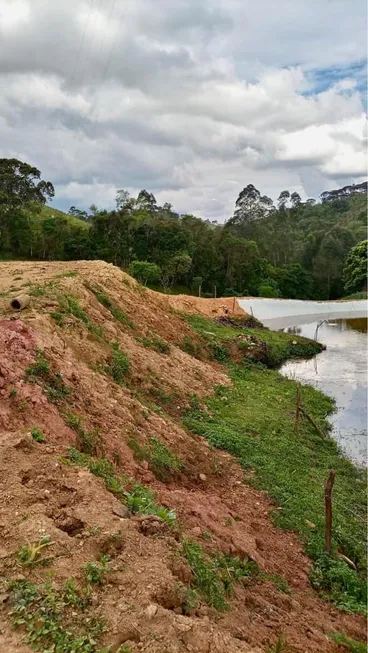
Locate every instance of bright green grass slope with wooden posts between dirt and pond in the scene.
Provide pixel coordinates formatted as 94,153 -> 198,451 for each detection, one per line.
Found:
185,364 -> 366,611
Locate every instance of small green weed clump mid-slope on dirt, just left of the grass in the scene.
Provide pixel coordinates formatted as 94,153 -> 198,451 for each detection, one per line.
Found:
128,437 -> 184,482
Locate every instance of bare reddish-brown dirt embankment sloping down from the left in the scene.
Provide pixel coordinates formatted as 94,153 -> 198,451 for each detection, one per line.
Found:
0,261 -> 364,653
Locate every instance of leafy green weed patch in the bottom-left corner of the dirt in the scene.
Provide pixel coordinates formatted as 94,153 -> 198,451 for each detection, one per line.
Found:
9,580 -> 107,653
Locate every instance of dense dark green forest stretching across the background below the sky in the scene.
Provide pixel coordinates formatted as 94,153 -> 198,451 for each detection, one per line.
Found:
0,159 -> 367,299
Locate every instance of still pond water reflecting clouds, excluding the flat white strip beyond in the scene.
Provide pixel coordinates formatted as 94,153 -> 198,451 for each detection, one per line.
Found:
280,318 -> 367,465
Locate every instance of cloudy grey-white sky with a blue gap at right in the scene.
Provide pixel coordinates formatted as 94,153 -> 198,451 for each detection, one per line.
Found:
0,0 -> 367,221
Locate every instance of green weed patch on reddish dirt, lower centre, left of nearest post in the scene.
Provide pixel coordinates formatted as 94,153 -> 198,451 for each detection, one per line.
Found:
182,540 -> 259,610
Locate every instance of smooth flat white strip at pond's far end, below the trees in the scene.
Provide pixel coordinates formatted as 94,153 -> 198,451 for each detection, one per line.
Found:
237,297 -> 368,329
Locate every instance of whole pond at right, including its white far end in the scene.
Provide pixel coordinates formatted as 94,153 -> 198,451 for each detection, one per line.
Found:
239,300 -> 367,465
